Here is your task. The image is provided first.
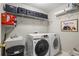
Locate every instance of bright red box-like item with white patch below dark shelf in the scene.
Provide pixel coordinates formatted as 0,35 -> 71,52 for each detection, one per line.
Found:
1,13 -> 16,25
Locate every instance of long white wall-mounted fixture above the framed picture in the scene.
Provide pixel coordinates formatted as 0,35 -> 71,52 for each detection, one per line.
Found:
54,3 -> 79,16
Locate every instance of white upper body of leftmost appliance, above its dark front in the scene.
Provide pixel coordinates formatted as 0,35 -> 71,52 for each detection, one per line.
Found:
5,36 -> 25,55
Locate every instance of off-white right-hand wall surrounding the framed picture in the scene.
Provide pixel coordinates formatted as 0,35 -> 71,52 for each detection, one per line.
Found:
49,4 -> 79,52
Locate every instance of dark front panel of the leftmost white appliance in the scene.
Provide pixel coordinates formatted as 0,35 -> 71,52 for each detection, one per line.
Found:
6,45 -> 24,56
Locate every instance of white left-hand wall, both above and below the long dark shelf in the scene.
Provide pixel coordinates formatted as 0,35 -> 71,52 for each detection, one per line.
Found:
3,3 -> 48,38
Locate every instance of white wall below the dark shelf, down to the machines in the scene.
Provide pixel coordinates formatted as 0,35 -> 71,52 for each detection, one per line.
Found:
10,17 -> 48,36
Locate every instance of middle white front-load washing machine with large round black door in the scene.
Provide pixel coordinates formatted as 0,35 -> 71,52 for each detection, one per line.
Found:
26,34 -> 49,56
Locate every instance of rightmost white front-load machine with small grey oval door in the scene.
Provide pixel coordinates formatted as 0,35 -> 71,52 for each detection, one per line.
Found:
49,33 -> 61,56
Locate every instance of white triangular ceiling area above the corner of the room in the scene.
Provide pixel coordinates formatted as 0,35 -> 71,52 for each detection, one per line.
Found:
27,3 -> 64,13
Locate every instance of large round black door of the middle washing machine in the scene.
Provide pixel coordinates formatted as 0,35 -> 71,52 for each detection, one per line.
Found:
35,39 -> 49,56
